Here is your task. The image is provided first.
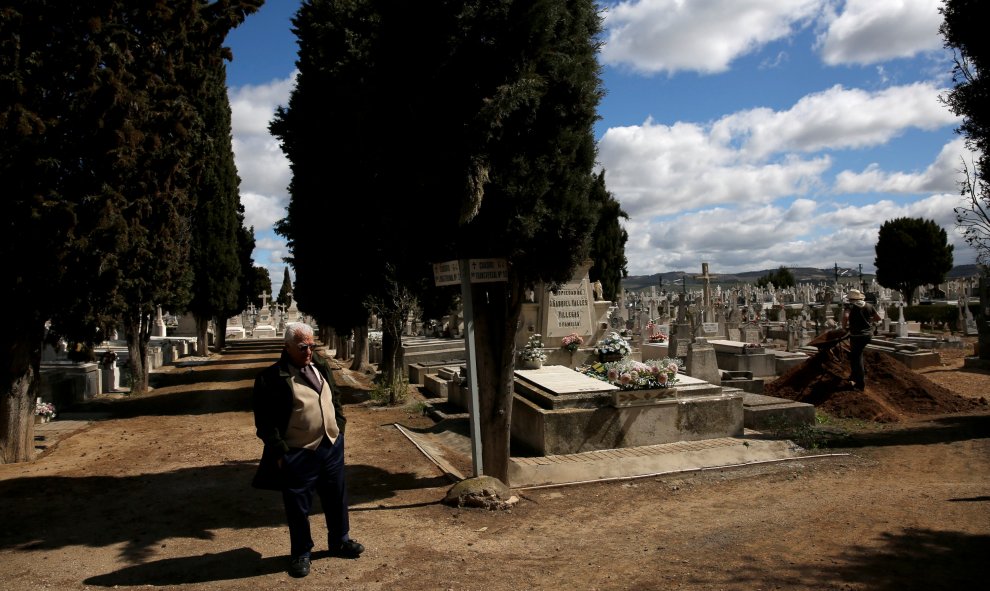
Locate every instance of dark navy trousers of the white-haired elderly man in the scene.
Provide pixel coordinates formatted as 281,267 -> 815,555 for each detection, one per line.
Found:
282,434 -> 350,557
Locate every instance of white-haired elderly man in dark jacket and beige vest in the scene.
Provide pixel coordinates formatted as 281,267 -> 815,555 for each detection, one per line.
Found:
253,323 -> 364,577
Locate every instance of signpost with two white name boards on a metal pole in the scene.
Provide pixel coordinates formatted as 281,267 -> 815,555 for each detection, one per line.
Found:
433,259 -> 509,476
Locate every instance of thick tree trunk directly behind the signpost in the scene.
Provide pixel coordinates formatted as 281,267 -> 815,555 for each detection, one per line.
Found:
465,279 -> 523,484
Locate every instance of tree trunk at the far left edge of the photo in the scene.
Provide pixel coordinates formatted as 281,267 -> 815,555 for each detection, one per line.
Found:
0,323 -> 44,464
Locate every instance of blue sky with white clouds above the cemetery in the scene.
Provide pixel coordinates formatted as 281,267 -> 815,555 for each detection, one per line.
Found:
221,0 -> 975,292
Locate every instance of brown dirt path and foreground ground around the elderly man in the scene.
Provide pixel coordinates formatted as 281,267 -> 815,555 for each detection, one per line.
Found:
0,342 -> 990,591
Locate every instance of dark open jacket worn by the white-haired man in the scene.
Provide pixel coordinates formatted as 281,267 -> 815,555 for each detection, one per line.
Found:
251,352 -> 347,490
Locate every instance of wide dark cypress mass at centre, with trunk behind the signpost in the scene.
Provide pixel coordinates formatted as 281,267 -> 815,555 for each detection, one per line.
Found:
271,0 -> 601,479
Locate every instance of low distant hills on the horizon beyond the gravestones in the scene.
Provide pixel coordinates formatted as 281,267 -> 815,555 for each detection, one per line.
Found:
622,265 -> 979,291
